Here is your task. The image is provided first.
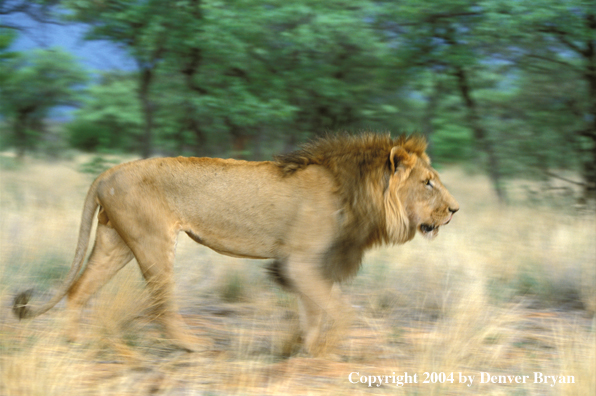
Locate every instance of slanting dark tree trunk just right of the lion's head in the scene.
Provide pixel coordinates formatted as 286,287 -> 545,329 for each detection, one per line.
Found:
454,66 -> 506,203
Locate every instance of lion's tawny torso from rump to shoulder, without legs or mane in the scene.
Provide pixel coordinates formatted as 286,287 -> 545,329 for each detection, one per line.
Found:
98,157 -> 339,258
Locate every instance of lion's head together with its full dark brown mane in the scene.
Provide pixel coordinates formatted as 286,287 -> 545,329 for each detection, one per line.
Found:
276,133 -> 459,281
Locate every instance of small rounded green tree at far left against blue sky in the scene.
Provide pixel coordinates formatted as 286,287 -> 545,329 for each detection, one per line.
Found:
0,49 -> 88,157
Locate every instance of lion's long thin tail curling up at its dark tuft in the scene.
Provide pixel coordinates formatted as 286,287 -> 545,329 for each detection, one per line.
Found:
12,178 -> 100,319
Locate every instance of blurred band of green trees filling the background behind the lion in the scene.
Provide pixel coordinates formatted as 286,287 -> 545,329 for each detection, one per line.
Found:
0,0 -> 596,200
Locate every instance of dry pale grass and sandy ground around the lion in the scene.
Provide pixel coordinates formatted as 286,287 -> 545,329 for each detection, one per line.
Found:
0,156 -> 596,395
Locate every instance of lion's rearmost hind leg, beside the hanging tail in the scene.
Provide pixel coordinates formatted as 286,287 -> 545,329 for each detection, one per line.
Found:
67,223 -> 133,341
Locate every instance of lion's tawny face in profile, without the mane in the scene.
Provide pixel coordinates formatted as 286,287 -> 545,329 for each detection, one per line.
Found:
400,158 -> 459,239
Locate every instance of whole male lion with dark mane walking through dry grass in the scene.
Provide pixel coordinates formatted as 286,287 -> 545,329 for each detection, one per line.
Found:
13,133 -> 459,354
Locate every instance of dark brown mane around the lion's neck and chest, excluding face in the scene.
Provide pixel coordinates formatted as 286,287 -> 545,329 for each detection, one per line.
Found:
275,133 -> 430,281
